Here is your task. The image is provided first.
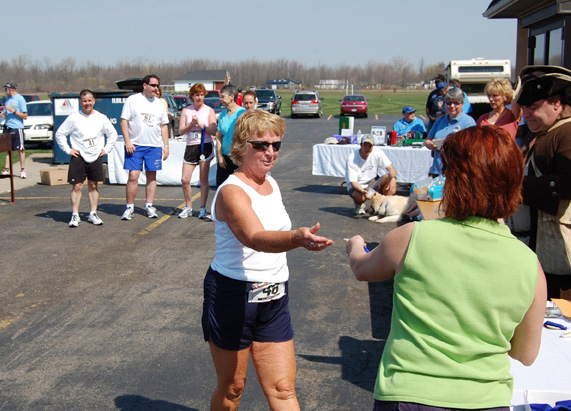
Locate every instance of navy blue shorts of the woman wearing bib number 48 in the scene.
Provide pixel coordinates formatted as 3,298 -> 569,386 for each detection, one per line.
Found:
202,267 -> 293,351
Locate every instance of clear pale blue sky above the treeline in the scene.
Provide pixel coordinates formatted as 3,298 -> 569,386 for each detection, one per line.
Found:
6,0 -> 516,68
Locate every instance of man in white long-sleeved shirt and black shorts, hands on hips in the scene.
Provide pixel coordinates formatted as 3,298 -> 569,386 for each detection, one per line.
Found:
55,90 -> 117,227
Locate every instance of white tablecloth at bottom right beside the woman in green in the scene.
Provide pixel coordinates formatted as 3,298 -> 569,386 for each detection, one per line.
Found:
510,318 -> 571,409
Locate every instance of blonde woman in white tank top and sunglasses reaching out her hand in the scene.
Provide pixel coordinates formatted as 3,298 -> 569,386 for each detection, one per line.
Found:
202,110 -> 333,410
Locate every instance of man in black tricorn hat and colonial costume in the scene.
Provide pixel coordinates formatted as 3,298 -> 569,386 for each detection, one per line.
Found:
515,66 -> 571,299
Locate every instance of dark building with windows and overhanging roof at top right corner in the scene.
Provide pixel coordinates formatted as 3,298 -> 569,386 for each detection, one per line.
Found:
483,0 -> 571,73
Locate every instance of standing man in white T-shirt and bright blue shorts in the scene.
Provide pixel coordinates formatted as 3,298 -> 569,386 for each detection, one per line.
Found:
121,74 -> 169,220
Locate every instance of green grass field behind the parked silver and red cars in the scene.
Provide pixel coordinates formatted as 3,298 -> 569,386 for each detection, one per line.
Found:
278,90 -> 430,116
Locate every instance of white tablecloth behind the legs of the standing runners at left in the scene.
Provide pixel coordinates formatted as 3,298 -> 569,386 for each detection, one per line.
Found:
107,140 -> 216,187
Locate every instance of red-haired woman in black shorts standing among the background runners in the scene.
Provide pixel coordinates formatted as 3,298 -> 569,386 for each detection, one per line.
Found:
178,83 -> 216,219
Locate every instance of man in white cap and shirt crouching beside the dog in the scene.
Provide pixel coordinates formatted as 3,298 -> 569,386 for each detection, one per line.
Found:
345,134 -> 397,215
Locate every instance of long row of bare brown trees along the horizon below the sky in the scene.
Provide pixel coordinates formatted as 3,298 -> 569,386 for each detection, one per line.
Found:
0,55 -> 444,92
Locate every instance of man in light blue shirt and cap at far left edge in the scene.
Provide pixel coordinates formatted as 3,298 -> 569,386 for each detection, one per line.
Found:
0,81 -> 28,178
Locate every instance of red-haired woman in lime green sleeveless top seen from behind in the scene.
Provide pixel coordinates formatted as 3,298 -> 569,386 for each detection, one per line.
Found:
347,126 -> 546,411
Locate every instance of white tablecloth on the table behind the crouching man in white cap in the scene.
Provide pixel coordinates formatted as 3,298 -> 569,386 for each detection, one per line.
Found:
313,144 -> 432,183
